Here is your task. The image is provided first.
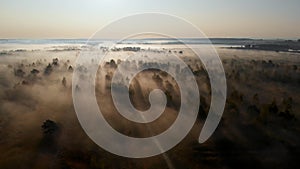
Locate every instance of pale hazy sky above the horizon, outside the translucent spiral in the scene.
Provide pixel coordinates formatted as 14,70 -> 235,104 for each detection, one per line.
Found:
0,0 -> 300,38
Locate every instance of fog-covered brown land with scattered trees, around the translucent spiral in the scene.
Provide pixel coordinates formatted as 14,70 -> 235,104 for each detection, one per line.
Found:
0,48 -> 300,168
